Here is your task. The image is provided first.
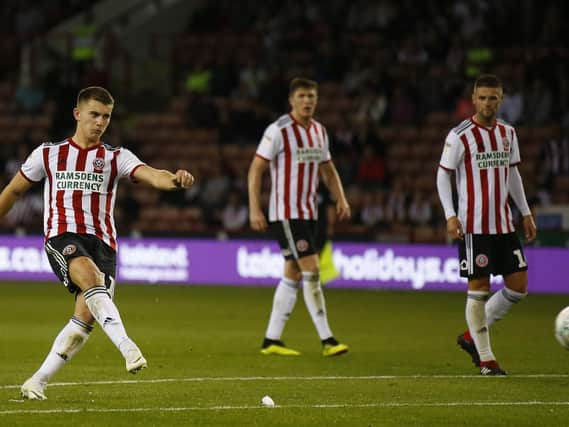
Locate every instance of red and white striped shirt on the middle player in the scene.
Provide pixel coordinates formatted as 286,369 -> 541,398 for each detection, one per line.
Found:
256,114 -> 332,221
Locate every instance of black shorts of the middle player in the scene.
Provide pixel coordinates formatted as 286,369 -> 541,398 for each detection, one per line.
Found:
271,219 -> 318,260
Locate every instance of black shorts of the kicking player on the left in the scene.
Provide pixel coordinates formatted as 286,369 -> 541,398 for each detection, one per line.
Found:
45,232 -> 117,294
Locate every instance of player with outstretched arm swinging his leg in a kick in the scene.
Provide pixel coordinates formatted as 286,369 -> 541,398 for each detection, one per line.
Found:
0,86 -> 194,400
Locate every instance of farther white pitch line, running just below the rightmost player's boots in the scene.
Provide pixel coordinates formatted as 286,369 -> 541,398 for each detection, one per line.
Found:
0,374 -> 569,390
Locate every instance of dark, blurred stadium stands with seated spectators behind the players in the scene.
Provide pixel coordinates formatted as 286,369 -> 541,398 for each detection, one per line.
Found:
0,0 -> 569,246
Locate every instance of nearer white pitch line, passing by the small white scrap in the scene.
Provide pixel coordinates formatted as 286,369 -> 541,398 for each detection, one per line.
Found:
0,400 -> 569,415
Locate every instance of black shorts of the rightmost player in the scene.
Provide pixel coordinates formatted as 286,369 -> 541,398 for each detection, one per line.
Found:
458,233 -> 528,278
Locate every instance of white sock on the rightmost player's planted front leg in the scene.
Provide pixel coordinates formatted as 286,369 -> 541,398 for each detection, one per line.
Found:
466,291 -> 496,362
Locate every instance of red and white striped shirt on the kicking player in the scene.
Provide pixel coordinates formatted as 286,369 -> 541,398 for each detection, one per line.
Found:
20,138 -> 144,250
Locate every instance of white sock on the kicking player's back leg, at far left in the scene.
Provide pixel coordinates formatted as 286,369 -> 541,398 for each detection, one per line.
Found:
33,317 -> 93,385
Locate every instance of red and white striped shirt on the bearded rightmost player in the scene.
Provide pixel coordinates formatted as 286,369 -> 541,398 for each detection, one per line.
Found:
440,119 -> 521,234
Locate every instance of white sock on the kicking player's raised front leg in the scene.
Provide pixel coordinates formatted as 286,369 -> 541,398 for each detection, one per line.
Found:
83,286 -> 130,356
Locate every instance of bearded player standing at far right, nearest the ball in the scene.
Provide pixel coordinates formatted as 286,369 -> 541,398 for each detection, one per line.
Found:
437,74 -> 536,375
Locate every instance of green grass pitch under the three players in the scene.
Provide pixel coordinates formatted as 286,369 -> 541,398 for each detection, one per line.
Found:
0,283 -> 569,427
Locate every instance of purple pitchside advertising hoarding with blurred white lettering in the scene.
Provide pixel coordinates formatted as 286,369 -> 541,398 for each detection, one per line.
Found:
0,236 -> 569,293
